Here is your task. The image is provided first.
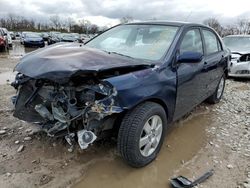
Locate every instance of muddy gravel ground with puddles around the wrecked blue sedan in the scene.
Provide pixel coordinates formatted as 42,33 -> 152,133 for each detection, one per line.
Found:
0,41 -> 250,188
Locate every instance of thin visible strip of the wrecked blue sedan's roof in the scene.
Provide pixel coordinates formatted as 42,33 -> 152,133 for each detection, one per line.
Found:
127,21 -> 207,27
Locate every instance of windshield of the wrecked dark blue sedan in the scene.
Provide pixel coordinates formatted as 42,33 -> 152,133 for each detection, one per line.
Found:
86,25 -> 178,60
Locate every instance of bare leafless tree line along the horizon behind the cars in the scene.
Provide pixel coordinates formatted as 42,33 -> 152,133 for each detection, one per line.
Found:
0,14 -> 250,37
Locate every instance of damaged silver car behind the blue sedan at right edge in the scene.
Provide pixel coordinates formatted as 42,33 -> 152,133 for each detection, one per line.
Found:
223,35 -> 250,78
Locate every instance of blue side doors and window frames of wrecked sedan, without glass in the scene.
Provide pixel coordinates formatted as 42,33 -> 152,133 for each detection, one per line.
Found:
173,26 -> 229,120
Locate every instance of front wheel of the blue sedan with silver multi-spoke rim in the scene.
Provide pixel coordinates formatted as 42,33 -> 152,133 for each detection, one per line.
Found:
117,102 -> 167,168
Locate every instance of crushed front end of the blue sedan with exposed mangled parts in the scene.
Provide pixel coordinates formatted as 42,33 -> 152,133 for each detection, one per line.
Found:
12,73 -> 123,149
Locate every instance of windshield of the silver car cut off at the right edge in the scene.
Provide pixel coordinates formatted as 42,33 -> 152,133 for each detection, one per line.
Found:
223,37 -> 250,52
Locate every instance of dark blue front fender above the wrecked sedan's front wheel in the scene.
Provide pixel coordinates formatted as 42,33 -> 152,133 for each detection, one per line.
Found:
106,67 -> 176,121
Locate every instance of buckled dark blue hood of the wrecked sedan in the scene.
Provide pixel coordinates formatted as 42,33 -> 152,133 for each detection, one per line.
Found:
14,43 -> 152,82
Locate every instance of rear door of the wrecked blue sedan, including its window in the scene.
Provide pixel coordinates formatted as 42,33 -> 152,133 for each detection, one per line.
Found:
202,29 -> 227,99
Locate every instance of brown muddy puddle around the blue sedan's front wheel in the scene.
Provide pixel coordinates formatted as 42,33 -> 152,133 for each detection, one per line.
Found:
73,110 -> 212,188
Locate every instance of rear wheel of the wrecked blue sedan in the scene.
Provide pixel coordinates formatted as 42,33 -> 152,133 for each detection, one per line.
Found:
207,74 -> 226,104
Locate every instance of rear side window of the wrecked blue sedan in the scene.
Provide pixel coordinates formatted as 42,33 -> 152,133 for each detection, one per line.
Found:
202,30 -> 221,55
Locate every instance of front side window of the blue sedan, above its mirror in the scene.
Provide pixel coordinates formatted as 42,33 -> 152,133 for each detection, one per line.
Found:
180,29 -> 203,54
